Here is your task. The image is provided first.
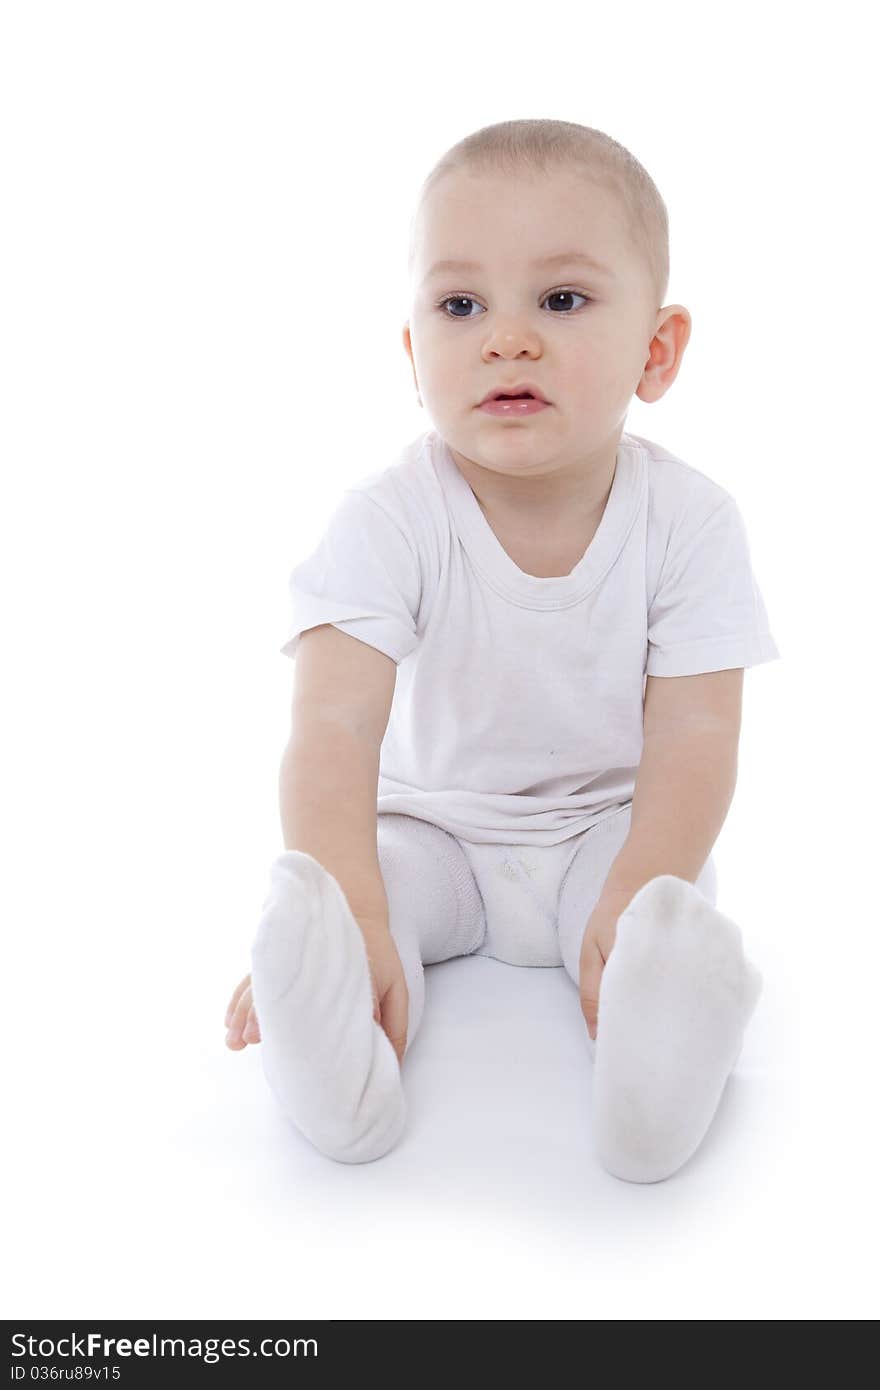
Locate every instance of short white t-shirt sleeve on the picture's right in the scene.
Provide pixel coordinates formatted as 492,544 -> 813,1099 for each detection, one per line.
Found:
645,493 -> 780,676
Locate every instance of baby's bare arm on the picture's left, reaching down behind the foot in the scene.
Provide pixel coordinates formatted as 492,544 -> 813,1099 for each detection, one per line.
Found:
227,624 -> 396,1051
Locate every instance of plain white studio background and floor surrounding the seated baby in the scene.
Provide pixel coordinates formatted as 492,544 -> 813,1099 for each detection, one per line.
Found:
0,0 -> 880,1319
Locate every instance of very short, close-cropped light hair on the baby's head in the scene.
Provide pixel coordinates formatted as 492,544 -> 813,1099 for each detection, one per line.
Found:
409,120 -> 669,309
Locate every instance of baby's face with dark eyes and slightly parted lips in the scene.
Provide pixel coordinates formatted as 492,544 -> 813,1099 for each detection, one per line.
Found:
403,172 -> 690,486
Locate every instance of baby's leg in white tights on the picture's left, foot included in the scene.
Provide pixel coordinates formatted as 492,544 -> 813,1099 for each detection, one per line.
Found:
252,815 -> 482,1163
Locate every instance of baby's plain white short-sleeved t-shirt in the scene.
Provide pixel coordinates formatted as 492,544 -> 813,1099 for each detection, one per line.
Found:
281,430 -> 780,845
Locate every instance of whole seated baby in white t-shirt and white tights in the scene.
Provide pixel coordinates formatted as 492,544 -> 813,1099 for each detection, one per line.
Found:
219,120 -> 780,1183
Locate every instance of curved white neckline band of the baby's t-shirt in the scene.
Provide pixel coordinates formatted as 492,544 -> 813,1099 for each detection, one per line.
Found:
425,430 -> 646,609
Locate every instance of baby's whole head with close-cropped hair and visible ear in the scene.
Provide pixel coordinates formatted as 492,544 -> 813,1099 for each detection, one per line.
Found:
403,120 -> 691,489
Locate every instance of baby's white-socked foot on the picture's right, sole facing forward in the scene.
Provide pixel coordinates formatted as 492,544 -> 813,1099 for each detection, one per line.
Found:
592,874 -> 762,1183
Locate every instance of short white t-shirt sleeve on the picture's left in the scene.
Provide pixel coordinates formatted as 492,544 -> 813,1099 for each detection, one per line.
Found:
281,491 -> 421,663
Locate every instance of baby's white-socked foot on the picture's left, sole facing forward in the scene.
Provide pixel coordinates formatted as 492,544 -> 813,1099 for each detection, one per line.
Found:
252,849 -> 406,1163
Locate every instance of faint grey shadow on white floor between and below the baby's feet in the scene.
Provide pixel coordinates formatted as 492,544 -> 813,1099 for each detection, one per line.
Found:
203,956 -> 773,1238
